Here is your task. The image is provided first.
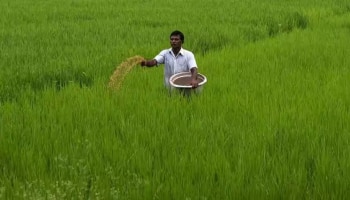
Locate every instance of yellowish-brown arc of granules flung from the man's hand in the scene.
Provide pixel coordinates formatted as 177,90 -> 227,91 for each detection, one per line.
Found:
108,55 -> 144,90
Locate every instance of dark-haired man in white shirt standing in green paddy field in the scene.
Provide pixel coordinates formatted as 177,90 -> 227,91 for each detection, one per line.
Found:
141,31 -> 198,88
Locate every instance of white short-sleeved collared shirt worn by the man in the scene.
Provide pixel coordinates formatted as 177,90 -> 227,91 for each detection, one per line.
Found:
154,48 -> 197,87
